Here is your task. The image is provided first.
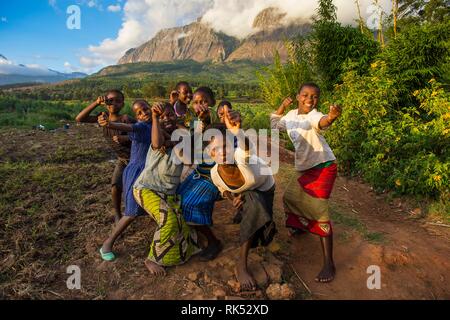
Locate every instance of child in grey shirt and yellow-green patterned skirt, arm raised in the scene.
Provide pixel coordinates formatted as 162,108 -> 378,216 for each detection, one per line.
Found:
134,103 -> 200,276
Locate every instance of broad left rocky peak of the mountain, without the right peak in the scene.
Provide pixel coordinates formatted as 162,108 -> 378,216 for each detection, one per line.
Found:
118,22 -> 239,64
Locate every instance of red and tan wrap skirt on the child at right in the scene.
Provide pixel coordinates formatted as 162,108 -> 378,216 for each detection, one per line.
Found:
283,163 -> 337,237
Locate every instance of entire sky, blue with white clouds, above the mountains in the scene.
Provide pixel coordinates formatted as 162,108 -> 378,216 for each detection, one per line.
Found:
0,0 -> 391,73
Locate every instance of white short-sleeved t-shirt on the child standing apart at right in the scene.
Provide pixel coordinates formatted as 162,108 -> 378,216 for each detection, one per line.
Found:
270,109 -> 336,171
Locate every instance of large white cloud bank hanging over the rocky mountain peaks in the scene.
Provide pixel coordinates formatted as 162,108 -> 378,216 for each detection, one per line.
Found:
80,0 -> 391,68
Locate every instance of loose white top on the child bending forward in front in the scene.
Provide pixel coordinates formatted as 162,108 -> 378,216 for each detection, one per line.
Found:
211,148 -> 275,194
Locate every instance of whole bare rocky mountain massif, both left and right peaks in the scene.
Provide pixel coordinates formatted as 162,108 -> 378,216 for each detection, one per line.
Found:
118,7 -> 310,64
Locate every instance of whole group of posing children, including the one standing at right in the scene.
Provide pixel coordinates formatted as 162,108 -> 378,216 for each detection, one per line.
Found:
76,82 -> 340,291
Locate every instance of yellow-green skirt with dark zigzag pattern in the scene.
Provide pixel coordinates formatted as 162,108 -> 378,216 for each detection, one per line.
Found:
133,189 -> 200,266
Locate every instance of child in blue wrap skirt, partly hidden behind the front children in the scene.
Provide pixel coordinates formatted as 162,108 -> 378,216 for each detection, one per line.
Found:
177,87 -> 223,261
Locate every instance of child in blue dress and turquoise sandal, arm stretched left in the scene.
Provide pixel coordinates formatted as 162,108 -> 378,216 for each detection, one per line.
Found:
98,100 -> 151,261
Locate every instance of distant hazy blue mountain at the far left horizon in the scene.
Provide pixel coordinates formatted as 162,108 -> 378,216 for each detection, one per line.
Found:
0,54 -> 87,85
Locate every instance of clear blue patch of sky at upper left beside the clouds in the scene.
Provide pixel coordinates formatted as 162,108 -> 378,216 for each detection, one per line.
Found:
0,0 -> 123,71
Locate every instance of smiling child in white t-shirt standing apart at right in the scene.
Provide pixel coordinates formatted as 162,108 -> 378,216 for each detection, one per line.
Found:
270,83 -> 341,282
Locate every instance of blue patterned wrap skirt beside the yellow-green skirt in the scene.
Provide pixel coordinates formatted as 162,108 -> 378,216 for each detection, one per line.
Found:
177,171 -> 220,226
